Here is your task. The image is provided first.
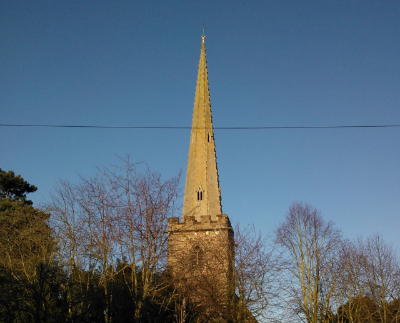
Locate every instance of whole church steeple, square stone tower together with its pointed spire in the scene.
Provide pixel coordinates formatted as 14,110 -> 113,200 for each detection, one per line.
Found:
168,34 -> 234,321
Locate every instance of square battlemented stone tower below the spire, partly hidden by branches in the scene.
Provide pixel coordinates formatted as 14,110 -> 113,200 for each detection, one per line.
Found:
168,215 -> 234,316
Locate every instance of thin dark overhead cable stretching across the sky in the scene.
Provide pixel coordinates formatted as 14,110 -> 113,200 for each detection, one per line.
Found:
0,123 -> 400,130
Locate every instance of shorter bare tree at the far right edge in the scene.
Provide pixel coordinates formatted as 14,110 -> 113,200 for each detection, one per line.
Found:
335,234 -> 400,323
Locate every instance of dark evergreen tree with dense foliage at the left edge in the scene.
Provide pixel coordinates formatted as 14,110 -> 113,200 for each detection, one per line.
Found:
0,171 -> 59,322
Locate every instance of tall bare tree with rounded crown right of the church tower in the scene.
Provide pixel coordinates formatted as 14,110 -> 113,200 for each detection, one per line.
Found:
276,203 -> 342,323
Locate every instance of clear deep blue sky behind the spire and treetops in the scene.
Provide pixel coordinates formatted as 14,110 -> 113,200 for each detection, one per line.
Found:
0,0 -> 400,247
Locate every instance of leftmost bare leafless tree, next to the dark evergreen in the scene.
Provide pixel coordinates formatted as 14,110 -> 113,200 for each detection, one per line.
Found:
47,176 -> 116,322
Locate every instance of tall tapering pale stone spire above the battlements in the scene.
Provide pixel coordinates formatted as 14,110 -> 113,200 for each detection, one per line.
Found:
183,35 -> 222,221
